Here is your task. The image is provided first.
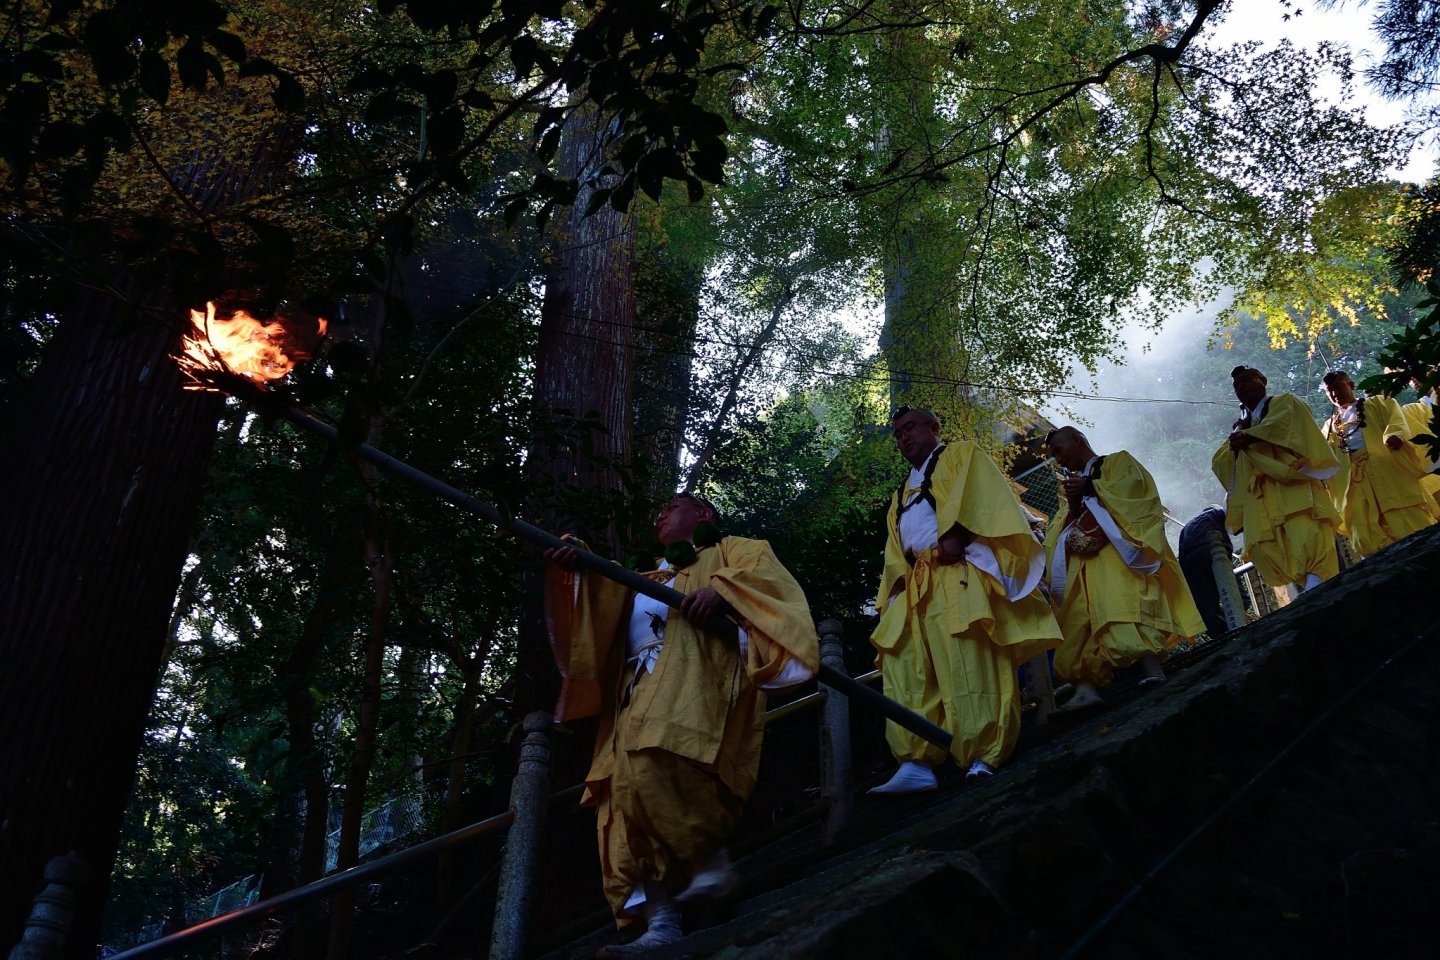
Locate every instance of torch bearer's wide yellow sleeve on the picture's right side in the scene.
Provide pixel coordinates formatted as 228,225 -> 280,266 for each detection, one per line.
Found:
706,537 -> 819,685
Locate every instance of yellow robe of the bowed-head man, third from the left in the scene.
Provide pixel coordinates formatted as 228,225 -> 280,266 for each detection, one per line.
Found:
1045,450 -> 1205,687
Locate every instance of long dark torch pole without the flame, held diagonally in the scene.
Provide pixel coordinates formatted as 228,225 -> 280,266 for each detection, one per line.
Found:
279,404 -> 952,750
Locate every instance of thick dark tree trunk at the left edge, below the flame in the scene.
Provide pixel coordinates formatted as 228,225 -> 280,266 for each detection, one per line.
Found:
0,294 -> 220,957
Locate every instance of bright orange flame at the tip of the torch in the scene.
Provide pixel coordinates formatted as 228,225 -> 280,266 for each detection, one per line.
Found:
176,302 -> 327,391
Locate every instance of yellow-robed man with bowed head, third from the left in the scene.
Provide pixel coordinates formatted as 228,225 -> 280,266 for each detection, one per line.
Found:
1045,426 -> 1205,715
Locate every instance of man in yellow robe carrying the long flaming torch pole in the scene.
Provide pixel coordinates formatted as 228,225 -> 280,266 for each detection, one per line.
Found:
546,495 -> 819,957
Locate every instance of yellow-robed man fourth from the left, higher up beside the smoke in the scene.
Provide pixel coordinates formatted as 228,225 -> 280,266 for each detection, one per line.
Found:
1211,366 -> 1341,592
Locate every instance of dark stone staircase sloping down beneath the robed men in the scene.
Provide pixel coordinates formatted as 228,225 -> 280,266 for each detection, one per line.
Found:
533,528 -> 1440,960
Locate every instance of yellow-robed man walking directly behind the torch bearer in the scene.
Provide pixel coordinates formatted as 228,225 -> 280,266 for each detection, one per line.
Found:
870,407 -> 1060,794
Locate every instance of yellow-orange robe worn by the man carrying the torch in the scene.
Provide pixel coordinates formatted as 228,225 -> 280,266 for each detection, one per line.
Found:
546,537 -> 819,925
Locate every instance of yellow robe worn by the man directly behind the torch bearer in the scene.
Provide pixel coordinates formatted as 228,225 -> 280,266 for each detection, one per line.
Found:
870,440 -> 1060,767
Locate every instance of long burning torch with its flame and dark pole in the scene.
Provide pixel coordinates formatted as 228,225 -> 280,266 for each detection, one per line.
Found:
176,302 -> 952,750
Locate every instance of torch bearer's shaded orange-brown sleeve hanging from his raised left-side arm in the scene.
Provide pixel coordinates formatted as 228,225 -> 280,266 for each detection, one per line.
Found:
544,555 -> 631,721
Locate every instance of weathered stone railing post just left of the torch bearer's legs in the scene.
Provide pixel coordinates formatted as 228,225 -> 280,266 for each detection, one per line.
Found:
490,710 -> 554,960
